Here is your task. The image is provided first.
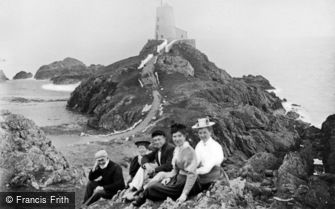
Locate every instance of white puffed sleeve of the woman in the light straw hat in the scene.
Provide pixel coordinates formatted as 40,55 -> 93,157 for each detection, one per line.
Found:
197,143 -> 223,175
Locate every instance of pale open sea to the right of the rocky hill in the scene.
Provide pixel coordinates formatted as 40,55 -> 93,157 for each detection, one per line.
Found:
199,37 -> 335,127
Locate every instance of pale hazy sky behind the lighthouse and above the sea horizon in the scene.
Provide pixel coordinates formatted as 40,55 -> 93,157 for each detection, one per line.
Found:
0,0 -> 335,78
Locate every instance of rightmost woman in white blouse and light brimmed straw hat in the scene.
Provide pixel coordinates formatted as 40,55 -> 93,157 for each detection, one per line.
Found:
192,118 -> 224,190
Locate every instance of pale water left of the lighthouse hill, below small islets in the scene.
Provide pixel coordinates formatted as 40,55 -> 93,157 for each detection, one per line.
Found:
0,79 -> 85,126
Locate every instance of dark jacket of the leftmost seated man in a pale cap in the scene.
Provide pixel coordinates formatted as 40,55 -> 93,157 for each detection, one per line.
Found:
88,160 -> 125,192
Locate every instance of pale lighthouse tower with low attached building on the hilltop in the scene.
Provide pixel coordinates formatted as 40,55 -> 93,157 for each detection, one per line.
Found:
155,0 -> 187,41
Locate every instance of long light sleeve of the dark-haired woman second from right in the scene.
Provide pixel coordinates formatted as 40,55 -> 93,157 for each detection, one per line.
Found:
182,148 -> 198,196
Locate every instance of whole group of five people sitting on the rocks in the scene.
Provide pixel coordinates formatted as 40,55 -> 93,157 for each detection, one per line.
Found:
80,118 -> 224,206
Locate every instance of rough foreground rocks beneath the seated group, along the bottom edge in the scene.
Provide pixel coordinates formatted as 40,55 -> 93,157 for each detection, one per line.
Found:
89,175 -> 265,209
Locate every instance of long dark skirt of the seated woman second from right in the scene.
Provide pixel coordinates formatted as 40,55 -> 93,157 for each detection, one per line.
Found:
143,174 -> 201,201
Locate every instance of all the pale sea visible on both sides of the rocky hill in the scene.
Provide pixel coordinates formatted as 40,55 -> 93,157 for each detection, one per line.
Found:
0,38 -> 335,130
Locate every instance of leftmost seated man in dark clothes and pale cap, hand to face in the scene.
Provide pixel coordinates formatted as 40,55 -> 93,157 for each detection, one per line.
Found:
84,150 -> 125,206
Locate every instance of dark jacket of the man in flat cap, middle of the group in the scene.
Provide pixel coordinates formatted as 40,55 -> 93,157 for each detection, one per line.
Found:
141,143 -> 174,173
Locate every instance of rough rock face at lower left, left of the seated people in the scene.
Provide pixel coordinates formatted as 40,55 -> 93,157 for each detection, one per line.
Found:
0,111 -> 85,189
